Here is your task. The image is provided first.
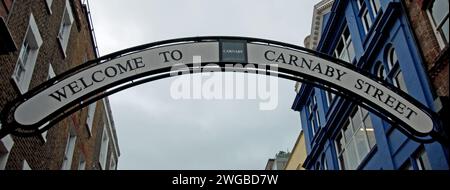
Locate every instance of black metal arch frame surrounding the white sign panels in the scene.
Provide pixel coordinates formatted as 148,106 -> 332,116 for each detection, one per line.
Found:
0,36 -> 448,143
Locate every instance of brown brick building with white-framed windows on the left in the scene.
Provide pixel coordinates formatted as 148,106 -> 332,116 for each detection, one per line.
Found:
0,0 -> 120,170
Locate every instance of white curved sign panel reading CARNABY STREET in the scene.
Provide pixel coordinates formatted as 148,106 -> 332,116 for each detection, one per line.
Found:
247,44 -> 433,133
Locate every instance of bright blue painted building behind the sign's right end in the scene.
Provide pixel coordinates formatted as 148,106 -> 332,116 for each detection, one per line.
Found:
292,0 -> 449,170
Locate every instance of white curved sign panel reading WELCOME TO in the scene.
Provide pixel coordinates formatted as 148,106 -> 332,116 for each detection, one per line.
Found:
14,42 -> 219,125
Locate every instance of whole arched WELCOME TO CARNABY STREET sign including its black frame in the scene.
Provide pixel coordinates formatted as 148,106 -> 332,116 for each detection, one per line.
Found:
0,37 -> 439,141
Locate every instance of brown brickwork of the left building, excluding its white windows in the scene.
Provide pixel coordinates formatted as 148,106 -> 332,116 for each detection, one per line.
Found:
0,0 -> 110,169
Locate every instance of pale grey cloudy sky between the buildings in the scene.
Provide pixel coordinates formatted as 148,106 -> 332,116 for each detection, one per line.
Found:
90,0 -> 319,170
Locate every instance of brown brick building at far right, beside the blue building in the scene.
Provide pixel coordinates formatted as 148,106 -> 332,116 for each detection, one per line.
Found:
405,0 -> 450,139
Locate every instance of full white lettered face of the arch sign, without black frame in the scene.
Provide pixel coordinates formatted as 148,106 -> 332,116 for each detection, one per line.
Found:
8,40 -> 433,134
